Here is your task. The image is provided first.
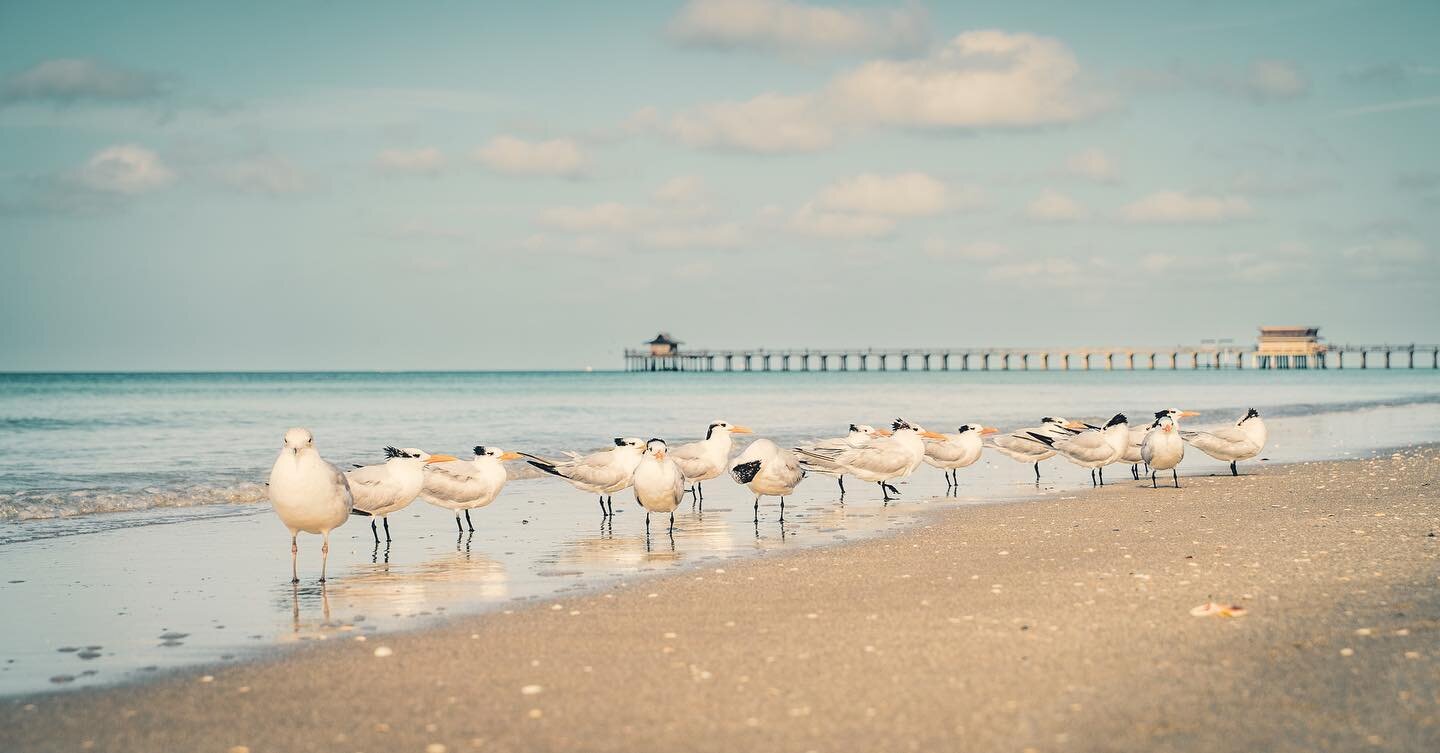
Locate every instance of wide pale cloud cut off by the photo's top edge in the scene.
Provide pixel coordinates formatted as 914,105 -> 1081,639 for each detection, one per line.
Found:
668,0 -> 929,55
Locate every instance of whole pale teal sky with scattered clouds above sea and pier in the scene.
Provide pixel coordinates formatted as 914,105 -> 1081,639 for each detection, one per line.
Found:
0,0 -> 1440,370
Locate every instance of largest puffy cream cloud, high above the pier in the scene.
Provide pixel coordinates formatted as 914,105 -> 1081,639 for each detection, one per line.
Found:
827,30 -> 1096,128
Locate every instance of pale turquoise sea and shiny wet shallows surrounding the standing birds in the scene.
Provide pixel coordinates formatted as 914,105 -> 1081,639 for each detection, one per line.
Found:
0,370 -> 1440,694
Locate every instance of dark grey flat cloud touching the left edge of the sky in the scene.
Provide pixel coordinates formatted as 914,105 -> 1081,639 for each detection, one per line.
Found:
0,58 -> 164,105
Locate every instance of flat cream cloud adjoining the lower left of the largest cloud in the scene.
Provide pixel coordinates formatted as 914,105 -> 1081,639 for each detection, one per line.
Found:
631,94 -> 835,153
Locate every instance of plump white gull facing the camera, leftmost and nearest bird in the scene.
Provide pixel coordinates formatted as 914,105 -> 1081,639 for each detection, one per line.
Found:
268,428 -> 354,583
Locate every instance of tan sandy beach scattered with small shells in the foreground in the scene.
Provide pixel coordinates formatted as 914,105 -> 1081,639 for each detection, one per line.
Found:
0,448 -> 1440,753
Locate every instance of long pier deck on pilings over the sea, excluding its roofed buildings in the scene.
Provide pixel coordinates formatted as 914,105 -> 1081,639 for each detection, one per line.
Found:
625,344 -> 1440,371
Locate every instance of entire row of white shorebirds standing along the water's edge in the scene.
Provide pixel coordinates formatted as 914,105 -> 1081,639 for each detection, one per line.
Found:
268,409 -> 1267,583
